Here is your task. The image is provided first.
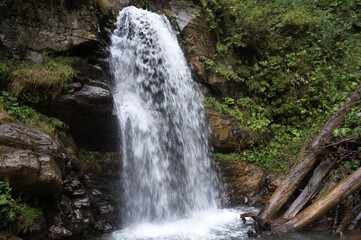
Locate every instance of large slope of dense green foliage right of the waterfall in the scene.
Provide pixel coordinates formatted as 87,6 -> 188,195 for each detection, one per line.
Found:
198,0 -> 361,172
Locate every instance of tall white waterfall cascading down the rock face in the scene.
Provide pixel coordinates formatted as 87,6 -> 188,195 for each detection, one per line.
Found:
110,7 -> 218,225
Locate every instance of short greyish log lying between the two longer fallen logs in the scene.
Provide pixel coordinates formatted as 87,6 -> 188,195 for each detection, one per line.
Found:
282,160 -> 333,220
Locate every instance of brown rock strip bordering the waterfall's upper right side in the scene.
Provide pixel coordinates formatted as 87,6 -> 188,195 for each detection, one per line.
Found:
170,1 -> 245,98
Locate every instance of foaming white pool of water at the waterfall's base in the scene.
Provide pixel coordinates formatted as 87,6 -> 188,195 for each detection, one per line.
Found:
103,208 -> 257,240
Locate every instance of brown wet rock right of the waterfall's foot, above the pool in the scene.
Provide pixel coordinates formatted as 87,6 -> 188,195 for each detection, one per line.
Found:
216,159 -> 265,207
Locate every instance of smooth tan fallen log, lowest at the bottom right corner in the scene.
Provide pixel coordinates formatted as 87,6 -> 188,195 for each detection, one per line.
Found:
274,168 -> 361,234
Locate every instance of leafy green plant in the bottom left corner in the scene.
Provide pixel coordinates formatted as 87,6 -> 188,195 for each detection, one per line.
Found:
0,181 -> 43,234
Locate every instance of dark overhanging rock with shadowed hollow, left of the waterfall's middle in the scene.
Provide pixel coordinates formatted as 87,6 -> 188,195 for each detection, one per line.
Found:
42,60 -> 119,151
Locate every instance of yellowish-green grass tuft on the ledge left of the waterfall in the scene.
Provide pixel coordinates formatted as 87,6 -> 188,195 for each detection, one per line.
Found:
11,57 -> 76,99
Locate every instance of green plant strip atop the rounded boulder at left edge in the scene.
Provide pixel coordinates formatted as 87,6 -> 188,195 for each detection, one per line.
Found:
0,91 -> 67,135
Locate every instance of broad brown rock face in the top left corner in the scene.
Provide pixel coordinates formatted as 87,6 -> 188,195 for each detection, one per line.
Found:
0,0 -> 98,51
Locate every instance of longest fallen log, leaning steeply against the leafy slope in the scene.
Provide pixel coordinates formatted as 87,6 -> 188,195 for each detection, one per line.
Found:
259,84 -> 361,219
